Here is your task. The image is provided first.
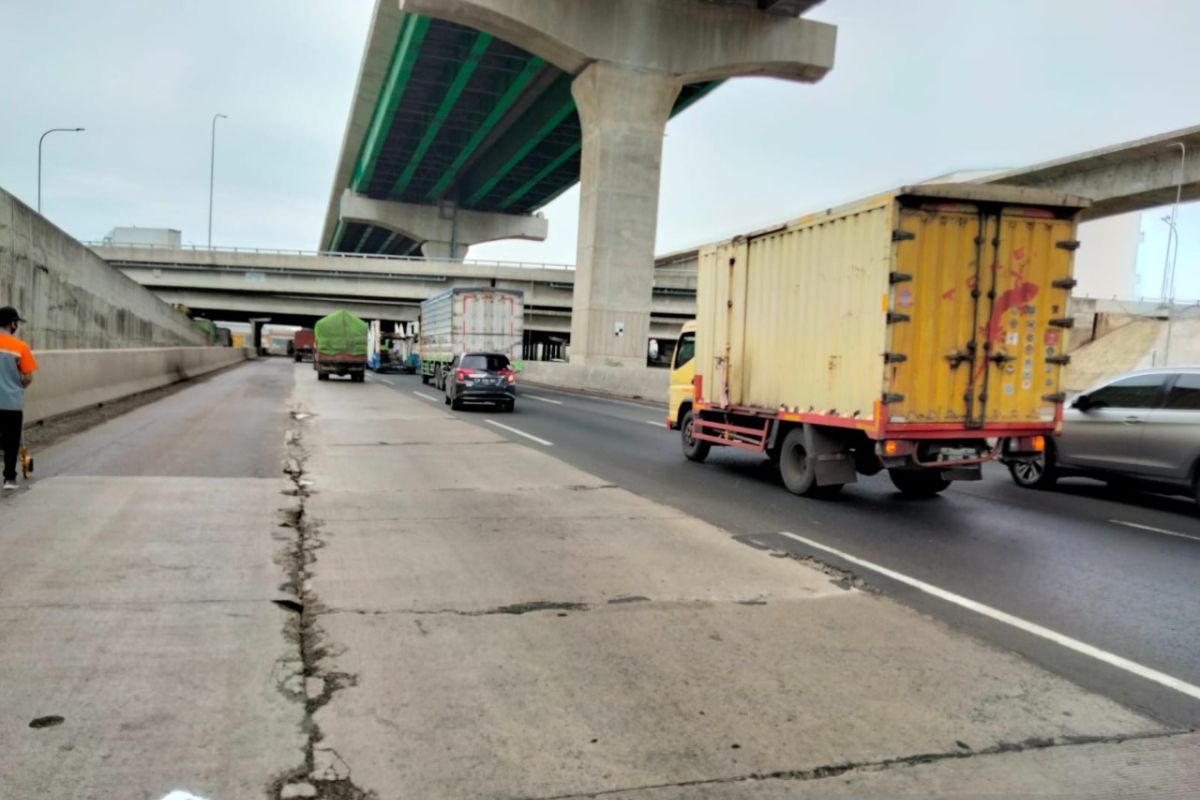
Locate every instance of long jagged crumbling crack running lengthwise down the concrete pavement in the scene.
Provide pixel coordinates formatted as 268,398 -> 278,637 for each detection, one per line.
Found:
268,409 -> 377,800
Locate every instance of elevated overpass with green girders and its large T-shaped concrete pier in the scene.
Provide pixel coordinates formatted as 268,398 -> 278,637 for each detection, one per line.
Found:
318,0 -> 836,365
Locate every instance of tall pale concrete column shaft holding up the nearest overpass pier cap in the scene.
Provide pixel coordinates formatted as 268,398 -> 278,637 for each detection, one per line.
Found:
571,61 -> 683,367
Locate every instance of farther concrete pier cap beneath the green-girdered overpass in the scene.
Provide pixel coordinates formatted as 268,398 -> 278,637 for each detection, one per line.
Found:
341,190 -> 550,260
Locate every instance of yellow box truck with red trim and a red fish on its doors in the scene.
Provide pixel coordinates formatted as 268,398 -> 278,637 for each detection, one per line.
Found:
668,184 -> 1088,495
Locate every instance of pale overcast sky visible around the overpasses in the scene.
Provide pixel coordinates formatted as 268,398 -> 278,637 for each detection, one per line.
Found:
0,0 -> 1200,299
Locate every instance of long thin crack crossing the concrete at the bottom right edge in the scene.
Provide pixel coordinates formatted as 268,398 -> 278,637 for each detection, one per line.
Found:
515,730 -> 1195,800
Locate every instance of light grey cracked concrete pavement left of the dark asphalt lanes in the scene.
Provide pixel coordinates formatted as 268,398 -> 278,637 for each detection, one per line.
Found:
0,360 -> 1200,800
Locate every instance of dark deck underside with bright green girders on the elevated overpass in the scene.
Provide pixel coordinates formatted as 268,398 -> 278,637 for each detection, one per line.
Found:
326,14 -> 716,254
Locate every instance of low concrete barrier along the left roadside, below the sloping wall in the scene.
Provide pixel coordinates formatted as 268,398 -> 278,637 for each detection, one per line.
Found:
25,347 -> 250,423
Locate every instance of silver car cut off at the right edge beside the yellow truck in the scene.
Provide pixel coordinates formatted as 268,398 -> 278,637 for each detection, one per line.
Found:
1008,367 -> 1200,504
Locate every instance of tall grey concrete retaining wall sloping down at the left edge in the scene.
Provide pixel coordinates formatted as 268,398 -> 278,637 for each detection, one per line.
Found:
0,190 -> 208,350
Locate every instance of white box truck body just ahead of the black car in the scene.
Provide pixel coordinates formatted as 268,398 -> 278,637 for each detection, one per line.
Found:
419,288 -> 524,387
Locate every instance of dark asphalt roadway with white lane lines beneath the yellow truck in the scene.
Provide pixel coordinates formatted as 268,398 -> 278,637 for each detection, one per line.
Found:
370,374 -> 1200,727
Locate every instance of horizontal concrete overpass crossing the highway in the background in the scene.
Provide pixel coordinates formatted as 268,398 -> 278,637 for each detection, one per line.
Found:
91,243 -> 696,339
